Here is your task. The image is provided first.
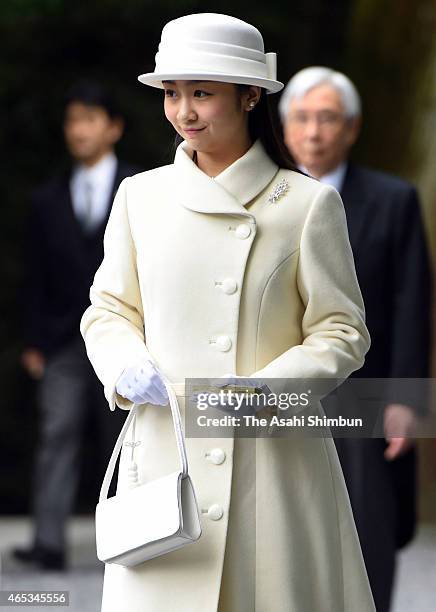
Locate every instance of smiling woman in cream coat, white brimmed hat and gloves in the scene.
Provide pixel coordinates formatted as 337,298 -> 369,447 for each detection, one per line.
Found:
81,9 -> 374,612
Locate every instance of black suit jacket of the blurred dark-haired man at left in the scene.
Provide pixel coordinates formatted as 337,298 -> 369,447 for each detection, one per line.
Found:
23,162 -> 138,355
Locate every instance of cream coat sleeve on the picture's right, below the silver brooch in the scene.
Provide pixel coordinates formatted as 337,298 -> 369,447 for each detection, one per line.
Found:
251,185 -> 370,395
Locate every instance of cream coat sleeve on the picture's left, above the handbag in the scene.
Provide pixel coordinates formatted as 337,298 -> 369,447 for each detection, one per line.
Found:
80,179 -> 151,410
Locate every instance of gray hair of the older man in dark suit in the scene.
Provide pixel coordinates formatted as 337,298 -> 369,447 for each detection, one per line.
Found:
279,66 -> 362,123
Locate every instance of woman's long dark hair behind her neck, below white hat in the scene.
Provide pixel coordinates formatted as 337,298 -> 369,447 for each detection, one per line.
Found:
174,84 -> 303,174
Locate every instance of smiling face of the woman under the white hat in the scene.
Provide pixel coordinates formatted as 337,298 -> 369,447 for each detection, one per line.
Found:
163,81 -> 259,154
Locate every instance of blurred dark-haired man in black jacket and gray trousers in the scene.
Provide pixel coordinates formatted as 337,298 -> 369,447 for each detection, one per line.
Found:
13,82 -> 137,569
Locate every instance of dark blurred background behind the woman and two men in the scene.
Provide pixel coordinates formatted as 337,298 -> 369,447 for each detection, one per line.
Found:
0,0 -> 435,514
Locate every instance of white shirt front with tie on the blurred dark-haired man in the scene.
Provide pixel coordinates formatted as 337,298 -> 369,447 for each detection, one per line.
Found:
70,153 -> 117,230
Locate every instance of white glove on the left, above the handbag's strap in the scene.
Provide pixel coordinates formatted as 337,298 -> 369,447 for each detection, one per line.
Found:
116,360 -> 169,406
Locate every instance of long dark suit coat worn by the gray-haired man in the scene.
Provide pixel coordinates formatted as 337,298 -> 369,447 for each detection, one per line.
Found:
336,163 -> 432,592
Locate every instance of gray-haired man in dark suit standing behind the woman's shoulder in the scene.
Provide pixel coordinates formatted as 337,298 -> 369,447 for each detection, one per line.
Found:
280,67 -> 431,612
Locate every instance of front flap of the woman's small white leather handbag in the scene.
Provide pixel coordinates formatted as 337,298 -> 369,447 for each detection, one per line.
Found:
95,472 -> 182,559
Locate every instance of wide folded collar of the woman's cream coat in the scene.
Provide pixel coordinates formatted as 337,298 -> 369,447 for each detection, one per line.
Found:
174,140 -> 278,217
